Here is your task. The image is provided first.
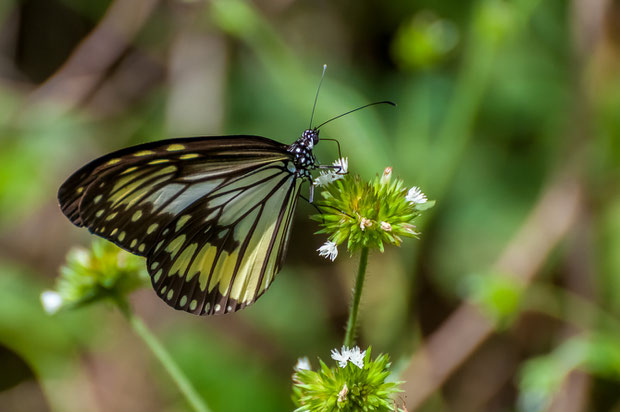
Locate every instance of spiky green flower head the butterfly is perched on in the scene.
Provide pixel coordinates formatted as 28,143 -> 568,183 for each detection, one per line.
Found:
312,167 -> 435,260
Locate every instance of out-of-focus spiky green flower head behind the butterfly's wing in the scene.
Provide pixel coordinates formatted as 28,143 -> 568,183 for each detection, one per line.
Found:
41,239 -> 148,314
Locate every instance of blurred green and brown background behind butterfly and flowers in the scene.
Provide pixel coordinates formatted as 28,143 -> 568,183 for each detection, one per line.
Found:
0,0 -> 620,412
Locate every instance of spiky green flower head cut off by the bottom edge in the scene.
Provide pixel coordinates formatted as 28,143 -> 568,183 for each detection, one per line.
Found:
293,347 -> 400,412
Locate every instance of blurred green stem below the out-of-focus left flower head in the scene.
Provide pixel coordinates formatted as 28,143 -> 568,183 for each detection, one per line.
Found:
116,301 -> 210,412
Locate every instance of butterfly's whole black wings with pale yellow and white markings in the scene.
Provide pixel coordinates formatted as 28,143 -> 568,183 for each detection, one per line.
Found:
58,136 -> 301,314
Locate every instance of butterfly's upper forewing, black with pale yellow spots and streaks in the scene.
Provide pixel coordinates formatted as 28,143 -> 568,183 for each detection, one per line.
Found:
58,136 -> 290,256
